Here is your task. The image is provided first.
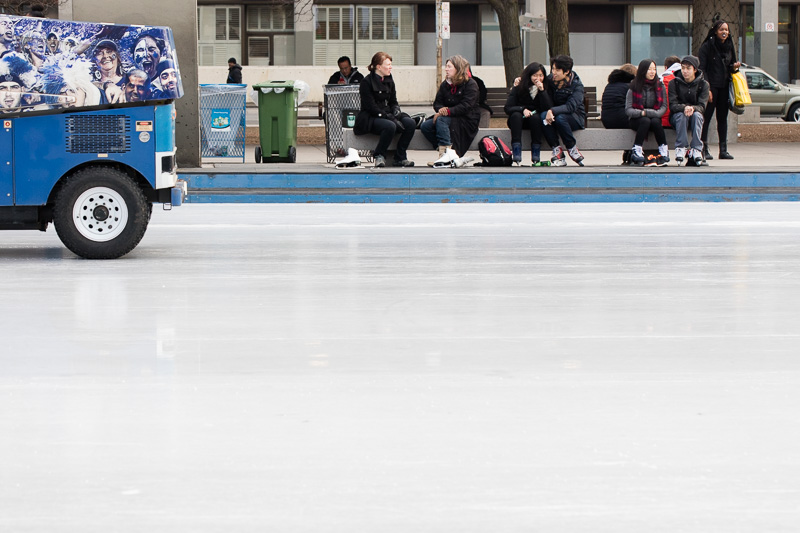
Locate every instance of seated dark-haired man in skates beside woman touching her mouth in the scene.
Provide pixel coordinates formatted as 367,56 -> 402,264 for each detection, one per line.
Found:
544,55 -> 586,167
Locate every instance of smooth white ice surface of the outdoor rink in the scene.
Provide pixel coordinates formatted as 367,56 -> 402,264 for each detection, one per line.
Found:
0,203 -> 800,533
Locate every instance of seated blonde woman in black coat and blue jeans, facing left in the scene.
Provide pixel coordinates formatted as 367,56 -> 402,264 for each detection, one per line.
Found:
420,56 -> 481,157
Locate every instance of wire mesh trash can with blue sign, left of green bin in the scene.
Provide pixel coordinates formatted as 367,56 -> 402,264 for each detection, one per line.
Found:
200,83 -> 247,162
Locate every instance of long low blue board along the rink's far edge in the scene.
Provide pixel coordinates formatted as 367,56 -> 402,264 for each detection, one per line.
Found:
180,172 -> 800,203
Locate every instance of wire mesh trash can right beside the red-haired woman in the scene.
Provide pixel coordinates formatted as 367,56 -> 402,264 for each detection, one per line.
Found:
324,85 -> 372,163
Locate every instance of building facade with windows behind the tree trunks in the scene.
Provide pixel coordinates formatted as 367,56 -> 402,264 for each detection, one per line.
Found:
198,0 -> 800,81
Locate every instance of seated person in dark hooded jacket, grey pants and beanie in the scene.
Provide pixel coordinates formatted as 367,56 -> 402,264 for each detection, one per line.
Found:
667,56 -> 708,166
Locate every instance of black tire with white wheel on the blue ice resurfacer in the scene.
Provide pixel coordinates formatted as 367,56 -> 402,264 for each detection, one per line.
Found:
53,167 -> 153,259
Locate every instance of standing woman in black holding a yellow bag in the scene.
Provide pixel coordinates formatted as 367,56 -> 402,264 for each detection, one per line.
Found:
697,20 -> 741,159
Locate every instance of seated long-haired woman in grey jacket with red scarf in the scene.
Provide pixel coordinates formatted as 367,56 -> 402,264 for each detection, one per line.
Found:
625,59 -> 669,167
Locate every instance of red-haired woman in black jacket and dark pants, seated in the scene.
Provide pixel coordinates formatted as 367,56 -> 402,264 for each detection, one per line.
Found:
353,52 -> 416,168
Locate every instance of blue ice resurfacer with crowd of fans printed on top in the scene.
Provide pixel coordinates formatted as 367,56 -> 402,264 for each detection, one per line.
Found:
0,14 -> 186,259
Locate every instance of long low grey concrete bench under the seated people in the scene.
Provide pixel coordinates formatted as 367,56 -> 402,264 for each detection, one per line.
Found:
344,128 -> 716,150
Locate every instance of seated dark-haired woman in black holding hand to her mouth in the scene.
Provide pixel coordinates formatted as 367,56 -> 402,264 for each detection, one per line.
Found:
503,62 -> 553,167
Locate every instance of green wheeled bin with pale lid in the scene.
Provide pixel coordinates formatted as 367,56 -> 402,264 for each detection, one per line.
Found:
253,80 -> 298,163
